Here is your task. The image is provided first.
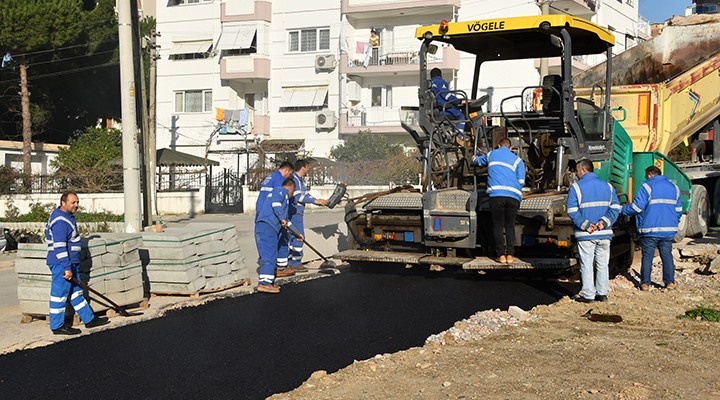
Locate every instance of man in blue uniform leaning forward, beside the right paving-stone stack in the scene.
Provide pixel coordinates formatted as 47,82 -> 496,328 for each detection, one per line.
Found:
255,178 -> 302,293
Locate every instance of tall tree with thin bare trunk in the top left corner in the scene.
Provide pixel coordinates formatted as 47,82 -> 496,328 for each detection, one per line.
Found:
0,0 -> 117,186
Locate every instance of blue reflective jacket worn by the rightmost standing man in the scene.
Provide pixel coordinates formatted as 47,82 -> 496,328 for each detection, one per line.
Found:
622,175 -> 682,238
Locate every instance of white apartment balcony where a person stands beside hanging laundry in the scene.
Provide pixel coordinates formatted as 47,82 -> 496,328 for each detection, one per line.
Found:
340,45 -> 460,76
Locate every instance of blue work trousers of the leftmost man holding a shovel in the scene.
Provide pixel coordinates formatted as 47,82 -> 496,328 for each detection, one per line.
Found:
49,264 -> 95,330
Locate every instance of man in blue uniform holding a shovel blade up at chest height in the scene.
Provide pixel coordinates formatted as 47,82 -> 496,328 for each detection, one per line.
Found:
288,160 -> 328,272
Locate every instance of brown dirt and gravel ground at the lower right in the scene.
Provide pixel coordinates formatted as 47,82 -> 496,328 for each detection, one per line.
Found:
271,248 -> 720,400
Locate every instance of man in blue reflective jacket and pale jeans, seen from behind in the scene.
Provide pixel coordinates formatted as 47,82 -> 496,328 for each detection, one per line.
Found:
567,159 -> 621,303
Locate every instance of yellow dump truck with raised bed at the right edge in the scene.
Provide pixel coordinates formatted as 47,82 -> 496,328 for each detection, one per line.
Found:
574,15 -> 720,240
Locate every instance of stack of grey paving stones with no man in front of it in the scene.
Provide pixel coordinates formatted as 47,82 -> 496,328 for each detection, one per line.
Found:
141,223 -> 249,294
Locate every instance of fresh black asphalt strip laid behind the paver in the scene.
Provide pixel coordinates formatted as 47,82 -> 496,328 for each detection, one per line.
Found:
0,268 -> 576,399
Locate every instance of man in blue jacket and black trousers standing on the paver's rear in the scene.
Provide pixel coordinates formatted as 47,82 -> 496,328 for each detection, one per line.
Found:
473,137 -> 525,264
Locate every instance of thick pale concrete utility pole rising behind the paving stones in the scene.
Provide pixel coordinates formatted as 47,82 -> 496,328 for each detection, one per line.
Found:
117,0 -> 142,233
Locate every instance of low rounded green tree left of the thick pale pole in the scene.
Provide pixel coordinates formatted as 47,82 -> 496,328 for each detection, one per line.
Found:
51,128 -> 122,192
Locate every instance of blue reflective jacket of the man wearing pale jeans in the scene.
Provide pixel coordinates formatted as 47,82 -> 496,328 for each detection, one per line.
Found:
567,172 -> 621,240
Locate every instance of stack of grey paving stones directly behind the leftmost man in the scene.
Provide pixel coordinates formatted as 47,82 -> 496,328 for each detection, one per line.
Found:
15,233 -> 144,315
